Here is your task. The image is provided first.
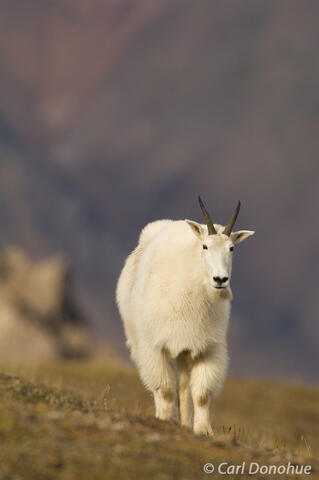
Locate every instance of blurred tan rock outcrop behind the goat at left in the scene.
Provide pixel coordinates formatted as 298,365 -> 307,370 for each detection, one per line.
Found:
0,247 -> 93,362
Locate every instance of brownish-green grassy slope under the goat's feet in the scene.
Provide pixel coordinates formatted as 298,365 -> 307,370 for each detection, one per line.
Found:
0,363 -> 319,480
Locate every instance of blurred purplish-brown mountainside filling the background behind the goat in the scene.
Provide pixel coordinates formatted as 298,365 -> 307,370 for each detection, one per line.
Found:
0,0 -> 319,381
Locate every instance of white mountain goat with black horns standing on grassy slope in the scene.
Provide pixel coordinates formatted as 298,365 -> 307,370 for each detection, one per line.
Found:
116,197 -> 255,435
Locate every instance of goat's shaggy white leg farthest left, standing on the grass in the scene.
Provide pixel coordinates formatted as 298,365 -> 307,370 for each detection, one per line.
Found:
139,348 -> 179,422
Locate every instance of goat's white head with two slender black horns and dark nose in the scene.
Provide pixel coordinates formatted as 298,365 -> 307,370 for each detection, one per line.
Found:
186,197 -> 255,290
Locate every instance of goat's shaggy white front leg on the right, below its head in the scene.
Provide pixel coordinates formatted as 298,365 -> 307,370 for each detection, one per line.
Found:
190,345 -> 228,436
